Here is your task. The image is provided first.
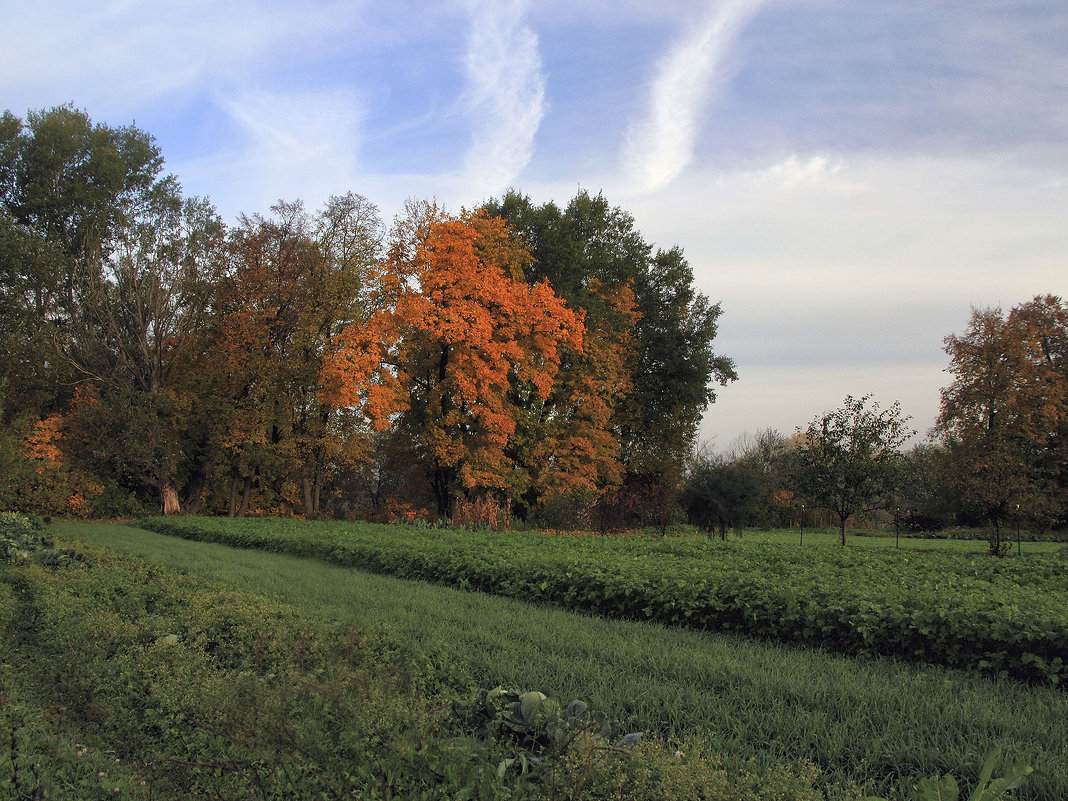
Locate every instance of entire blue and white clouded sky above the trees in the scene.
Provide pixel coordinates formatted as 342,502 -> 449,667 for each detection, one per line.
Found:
0,0 -> 1068,451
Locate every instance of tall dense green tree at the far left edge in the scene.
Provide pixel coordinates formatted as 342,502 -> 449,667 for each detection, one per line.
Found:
0,106 -> 163,418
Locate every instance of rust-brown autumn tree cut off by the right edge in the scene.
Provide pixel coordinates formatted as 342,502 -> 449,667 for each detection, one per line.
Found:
937,296 -> 1068,553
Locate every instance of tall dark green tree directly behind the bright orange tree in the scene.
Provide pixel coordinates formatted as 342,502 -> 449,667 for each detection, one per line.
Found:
484,191 -> 737,517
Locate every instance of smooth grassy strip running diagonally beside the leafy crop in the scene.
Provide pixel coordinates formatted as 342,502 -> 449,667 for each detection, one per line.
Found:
54,523 -> 1068,799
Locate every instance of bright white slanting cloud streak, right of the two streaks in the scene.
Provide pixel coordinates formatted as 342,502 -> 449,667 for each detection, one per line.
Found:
623,0 -> 764,191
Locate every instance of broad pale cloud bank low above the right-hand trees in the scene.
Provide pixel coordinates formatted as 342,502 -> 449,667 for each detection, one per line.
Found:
615,153 -> 1068,446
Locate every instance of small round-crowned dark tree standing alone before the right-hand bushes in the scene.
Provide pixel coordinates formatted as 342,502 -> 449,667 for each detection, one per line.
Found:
794,395 -> 915,547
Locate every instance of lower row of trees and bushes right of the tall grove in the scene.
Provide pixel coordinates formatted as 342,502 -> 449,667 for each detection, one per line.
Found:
681,295 -> 1068,555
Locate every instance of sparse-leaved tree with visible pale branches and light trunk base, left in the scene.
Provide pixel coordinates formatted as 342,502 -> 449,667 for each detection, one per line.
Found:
59,180 -> 226,514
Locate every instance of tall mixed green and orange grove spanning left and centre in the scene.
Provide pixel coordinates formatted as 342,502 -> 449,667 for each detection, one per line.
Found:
0,106 -> 737,520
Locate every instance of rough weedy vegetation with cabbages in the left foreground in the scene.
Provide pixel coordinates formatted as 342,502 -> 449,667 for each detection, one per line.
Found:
0,514 -> 897,801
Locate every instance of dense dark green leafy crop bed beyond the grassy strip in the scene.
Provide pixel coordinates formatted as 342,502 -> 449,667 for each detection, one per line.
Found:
141,518 -> 1068,684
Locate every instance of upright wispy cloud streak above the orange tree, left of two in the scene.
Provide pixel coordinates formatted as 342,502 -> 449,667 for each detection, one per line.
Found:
465,0 -> 546,192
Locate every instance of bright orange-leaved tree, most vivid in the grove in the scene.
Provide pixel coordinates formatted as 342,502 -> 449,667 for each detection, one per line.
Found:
323,203 -> 583,515
